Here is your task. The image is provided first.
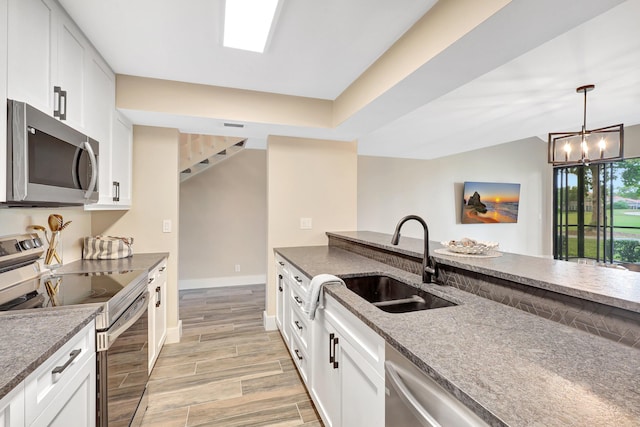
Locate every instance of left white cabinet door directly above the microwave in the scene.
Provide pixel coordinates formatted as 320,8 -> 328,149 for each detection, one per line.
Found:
7,0 -> 58,115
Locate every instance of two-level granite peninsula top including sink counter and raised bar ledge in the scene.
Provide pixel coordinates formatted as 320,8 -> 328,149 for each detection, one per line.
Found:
276,232 -> 640,427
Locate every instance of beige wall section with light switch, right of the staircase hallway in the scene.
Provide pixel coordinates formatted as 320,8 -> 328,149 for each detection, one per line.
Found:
267,136 -> 358,316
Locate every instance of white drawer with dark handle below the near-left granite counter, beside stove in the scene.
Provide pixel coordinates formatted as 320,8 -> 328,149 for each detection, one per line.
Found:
25,321 -> 96,425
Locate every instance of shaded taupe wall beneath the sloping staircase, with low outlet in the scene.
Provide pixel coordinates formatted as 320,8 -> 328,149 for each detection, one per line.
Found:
179,150 -> 267,288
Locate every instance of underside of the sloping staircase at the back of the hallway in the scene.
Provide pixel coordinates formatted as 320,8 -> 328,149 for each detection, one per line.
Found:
180,133 -> 247,182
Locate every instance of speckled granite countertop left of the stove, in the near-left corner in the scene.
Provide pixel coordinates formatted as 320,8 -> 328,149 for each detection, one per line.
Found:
0,304 -> 102,399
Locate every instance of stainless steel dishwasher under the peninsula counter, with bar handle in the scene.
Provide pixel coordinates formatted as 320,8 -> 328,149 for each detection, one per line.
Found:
384,344 -> 489,427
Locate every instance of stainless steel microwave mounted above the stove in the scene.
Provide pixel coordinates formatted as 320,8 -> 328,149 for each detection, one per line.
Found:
4,100 -> 99,206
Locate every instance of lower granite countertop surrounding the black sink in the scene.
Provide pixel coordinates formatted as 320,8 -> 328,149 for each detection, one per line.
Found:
276,246 -> 640,427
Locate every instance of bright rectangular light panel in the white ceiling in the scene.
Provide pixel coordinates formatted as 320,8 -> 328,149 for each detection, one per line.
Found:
223,0 -> 279,53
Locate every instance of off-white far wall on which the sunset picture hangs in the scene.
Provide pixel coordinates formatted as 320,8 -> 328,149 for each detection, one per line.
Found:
358,138 -> 552,256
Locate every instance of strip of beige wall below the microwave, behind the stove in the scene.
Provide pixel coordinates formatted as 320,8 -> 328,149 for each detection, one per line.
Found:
0,207 -> 91,264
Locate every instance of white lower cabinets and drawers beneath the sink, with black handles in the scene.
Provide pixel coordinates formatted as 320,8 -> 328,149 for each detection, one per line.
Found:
275,254 -> 385,427
